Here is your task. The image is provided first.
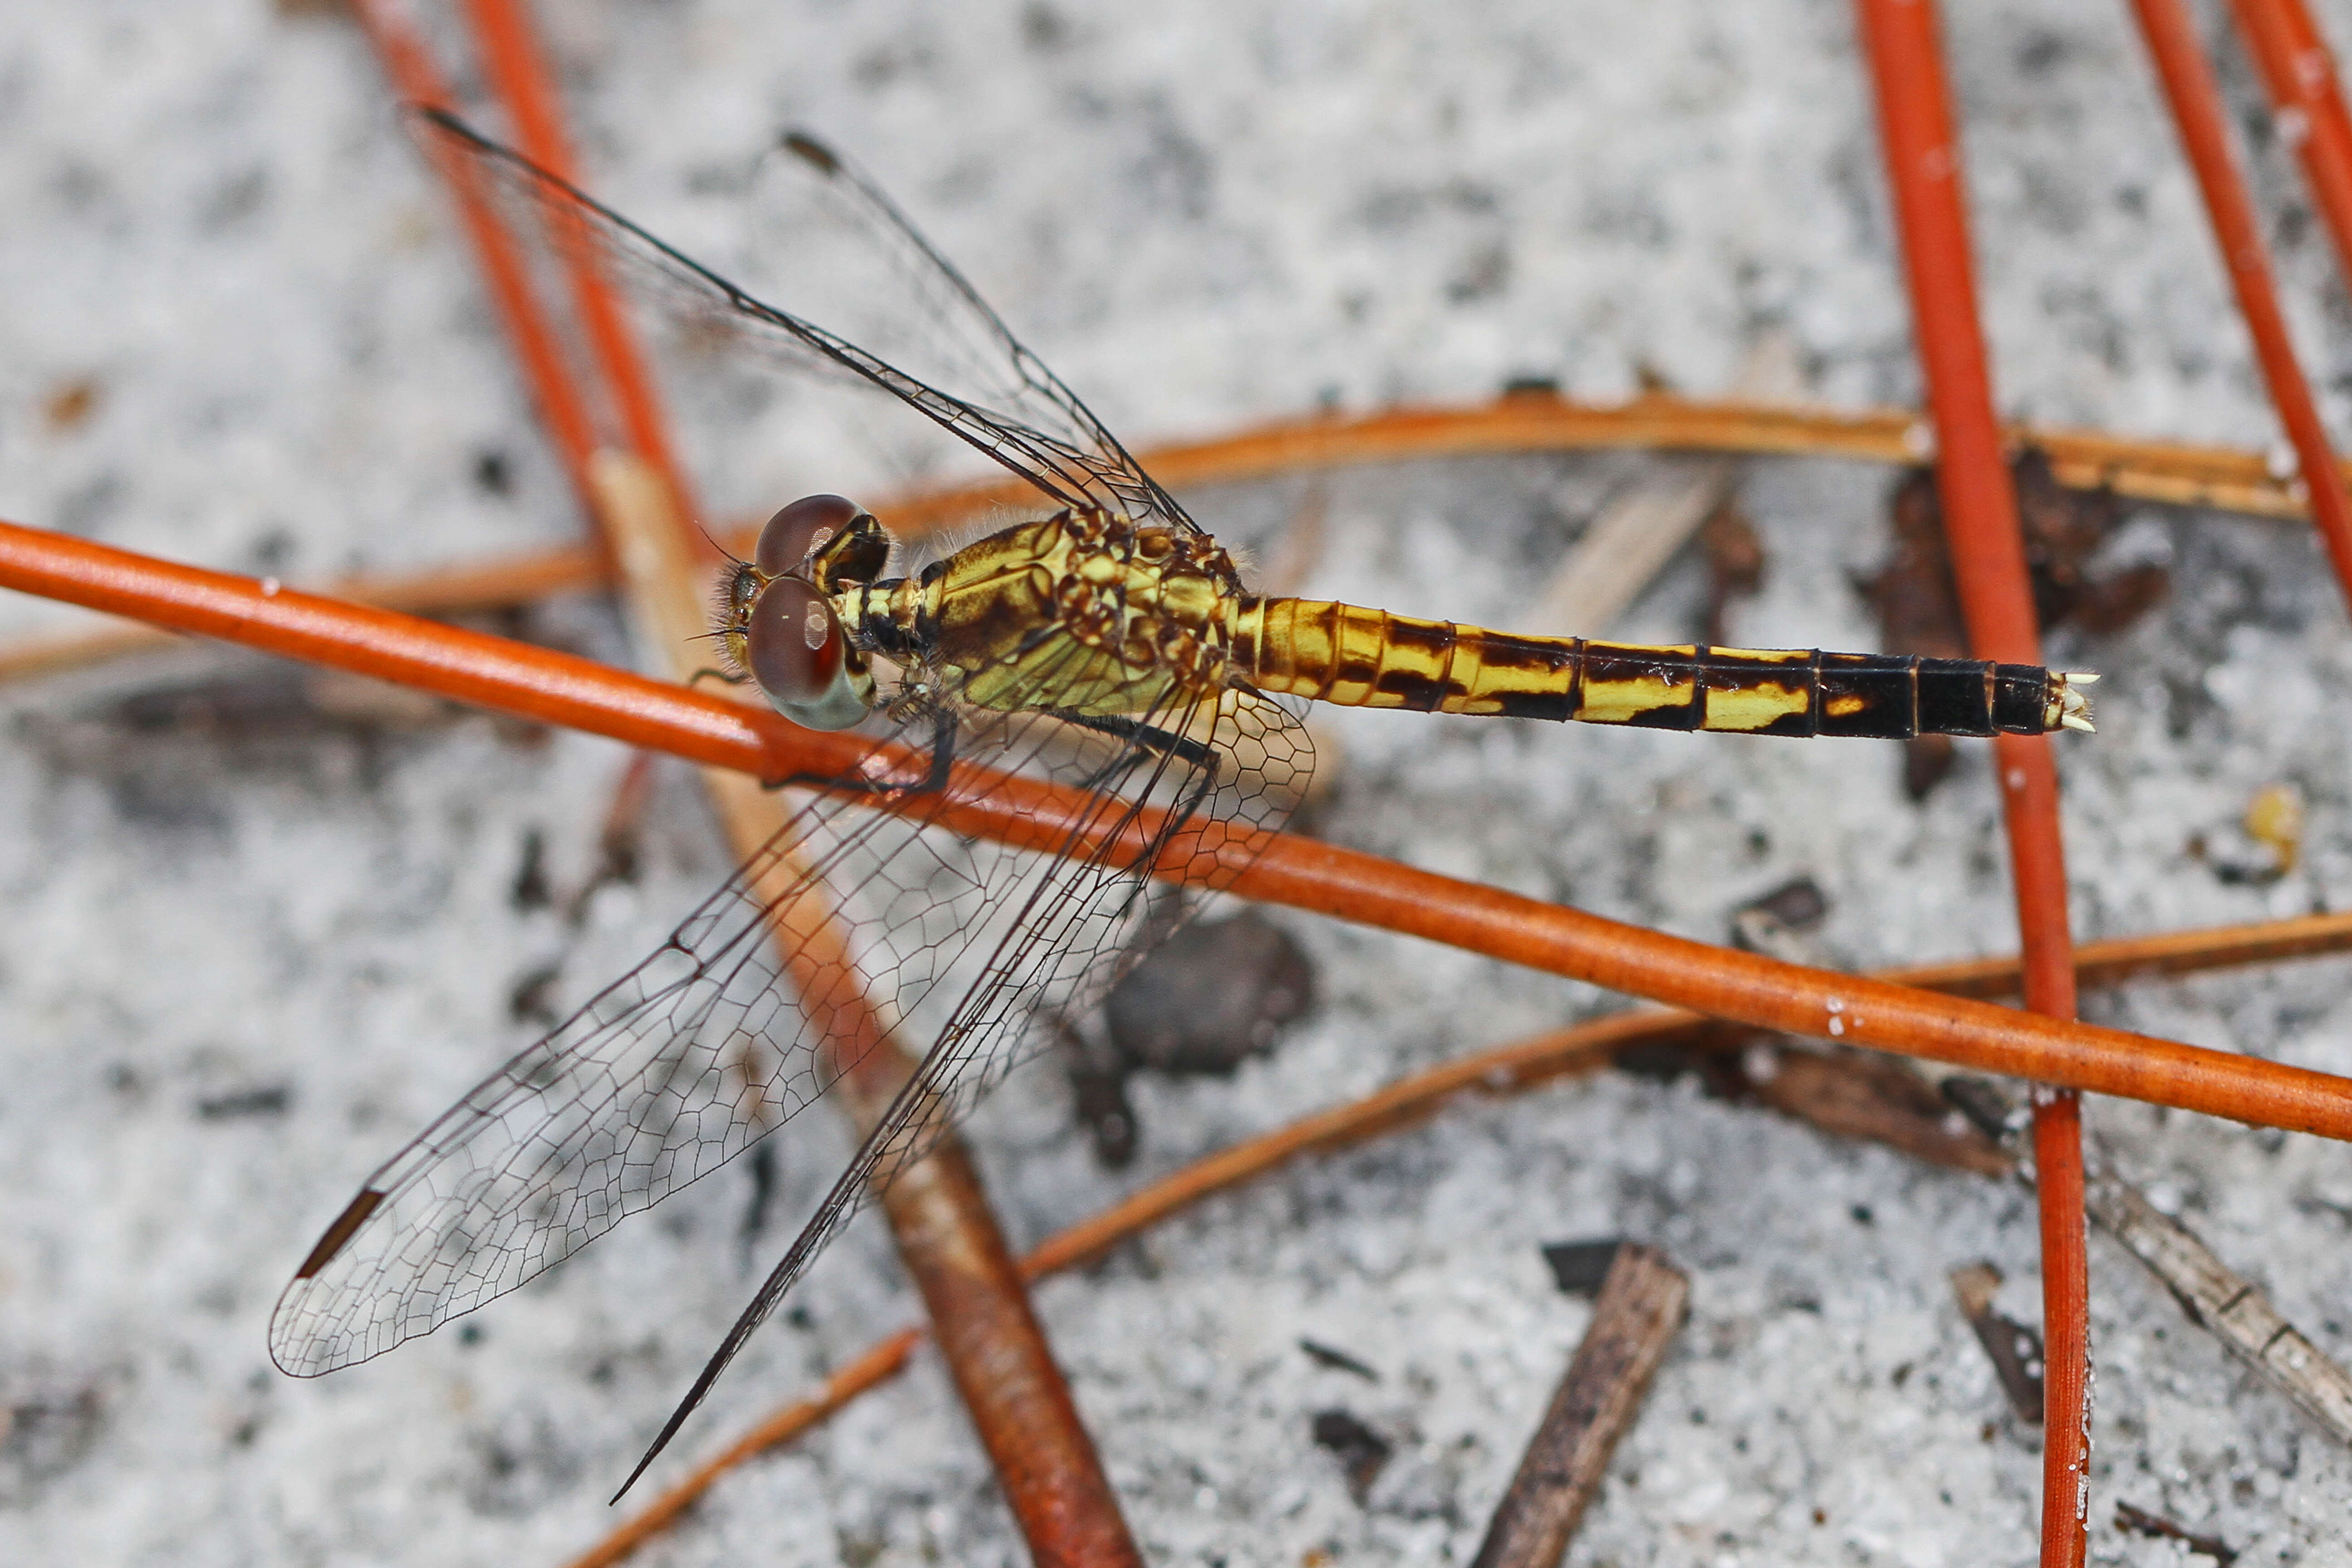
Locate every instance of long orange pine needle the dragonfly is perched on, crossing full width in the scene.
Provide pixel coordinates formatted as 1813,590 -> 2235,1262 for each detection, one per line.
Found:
0,522 -> 2352,1140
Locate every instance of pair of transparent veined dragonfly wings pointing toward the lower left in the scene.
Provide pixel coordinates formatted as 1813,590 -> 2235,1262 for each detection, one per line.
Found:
270,644 -> 1313,1401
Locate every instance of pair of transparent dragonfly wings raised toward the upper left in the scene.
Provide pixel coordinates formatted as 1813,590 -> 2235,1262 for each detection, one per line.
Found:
412,108 -> 1197,531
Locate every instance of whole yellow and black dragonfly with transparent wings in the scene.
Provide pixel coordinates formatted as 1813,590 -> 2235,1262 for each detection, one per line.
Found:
270,108 -> 2096,1493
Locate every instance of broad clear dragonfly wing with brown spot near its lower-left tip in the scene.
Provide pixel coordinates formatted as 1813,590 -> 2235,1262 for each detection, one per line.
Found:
270,701 -> 974,1375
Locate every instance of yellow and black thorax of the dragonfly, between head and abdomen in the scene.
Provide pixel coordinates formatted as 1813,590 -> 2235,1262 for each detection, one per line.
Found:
833,508 -> 1242,715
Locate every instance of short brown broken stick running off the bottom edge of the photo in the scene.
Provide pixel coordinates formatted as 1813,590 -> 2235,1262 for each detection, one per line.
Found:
1475,1241 -> 1691,1568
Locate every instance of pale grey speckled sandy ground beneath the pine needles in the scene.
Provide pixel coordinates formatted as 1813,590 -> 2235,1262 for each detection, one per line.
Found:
0,0 -> 2352,1568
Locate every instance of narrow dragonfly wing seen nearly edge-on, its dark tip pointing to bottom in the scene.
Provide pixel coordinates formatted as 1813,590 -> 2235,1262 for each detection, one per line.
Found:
621,691 -> 1315,1493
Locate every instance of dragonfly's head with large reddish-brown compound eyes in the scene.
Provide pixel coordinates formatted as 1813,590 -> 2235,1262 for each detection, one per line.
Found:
720,496 -> 889,729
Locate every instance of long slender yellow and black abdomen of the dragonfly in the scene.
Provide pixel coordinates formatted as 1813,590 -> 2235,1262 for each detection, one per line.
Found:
1232,599 -> 2088,738
